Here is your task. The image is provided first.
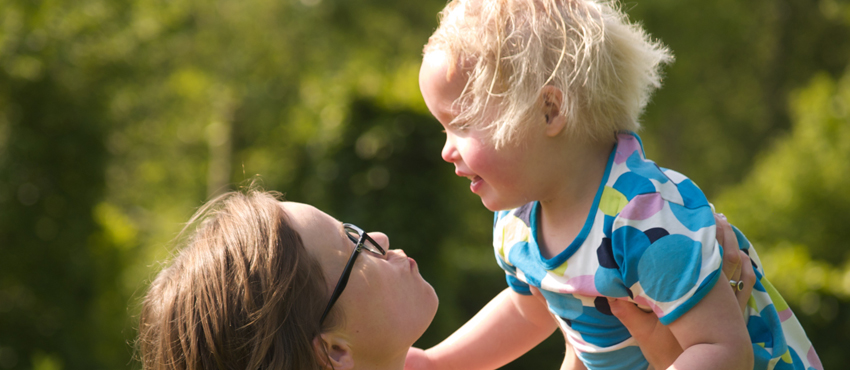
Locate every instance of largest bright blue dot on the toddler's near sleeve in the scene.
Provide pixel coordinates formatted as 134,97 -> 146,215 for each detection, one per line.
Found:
638,235 -> 702,302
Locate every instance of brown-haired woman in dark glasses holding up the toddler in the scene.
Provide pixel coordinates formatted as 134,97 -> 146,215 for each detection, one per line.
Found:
137,190 -> 752,370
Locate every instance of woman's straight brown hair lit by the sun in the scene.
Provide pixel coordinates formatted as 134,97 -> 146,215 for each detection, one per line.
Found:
137,190 -> 333,370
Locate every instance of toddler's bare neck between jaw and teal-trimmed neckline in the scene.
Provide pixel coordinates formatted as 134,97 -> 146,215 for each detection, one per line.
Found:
537,137 -> 613,259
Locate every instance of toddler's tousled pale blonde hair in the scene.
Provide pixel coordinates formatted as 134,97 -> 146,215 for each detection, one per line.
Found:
424,0 -> 673,147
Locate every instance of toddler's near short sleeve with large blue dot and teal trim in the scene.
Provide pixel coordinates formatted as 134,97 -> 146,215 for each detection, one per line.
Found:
611,193 -> 723,325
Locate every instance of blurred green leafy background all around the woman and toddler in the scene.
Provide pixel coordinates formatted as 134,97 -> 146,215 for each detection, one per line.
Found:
0,0 -> 850,370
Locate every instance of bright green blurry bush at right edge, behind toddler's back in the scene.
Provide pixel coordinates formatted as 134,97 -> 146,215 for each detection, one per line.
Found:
717,74 -> 850,368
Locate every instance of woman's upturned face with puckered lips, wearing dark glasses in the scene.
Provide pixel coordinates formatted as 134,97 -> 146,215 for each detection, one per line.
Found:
282,202 -> 437,362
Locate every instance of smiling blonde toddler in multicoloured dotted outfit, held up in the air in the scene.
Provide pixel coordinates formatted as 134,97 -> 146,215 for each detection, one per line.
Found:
408,0 -> 822,370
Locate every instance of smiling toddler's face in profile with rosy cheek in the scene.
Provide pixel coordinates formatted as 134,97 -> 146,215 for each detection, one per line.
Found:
419,51 -> 537,211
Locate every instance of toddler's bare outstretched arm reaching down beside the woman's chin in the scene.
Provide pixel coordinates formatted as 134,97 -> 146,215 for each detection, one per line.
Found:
405,288 -> 558,370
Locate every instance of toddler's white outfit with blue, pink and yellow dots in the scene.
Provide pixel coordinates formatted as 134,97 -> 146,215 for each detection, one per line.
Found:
493,134 -> 823,370
